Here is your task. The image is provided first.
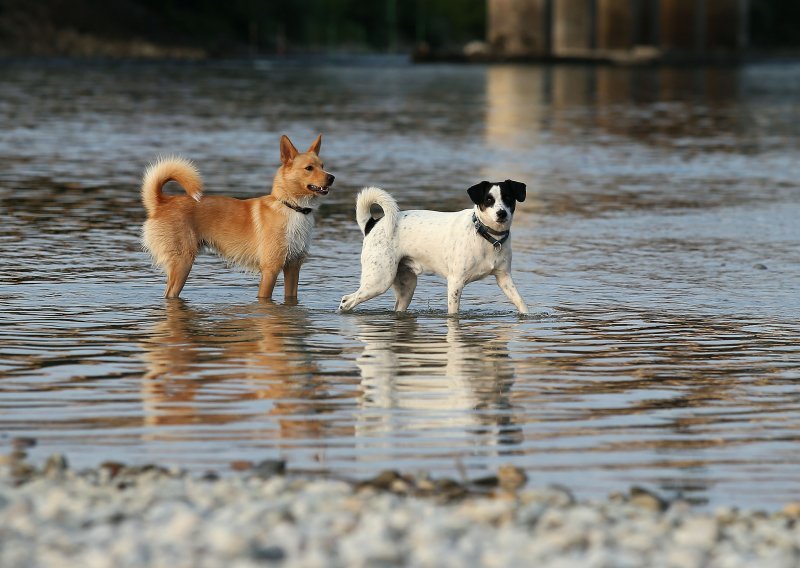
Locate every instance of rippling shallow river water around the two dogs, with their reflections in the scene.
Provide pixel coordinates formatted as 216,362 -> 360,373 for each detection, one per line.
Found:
0,60 -> 800,508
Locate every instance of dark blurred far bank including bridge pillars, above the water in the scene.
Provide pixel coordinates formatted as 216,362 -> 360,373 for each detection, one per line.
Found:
0,0 -> 800,60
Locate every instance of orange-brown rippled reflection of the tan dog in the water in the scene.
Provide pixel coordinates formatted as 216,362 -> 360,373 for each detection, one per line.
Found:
141,300 -> 352,440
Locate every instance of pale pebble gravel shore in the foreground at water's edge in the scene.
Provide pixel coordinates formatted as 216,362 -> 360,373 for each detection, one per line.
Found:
0,456 -> 800,568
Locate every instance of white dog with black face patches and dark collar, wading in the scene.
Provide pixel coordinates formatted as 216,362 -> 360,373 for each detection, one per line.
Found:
339,180 -> 528,314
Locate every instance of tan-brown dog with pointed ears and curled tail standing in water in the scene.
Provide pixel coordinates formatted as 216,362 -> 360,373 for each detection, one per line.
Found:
142,134 -> 334,299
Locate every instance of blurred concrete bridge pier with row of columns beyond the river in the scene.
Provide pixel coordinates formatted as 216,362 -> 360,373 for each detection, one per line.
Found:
487,0 -> 750,58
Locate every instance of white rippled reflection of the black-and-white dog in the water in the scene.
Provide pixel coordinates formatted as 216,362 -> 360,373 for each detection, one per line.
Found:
356,317 -> 521,446
